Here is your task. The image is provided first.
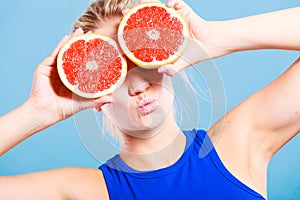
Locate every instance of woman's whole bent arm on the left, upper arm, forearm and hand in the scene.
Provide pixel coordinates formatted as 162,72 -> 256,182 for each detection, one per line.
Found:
0,30 -> 111,200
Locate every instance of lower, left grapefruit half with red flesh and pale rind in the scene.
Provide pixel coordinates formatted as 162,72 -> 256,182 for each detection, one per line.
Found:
57,33 -> 127,98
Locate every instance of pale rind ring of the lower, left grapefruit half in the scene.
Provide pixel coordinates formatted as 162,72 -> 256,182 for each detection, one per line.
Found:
57,33 -> 127,98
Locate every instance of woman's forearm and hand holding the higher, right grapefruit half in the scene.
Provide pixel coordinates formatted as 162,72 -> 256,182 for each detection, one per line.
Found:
159,0 -> 300,75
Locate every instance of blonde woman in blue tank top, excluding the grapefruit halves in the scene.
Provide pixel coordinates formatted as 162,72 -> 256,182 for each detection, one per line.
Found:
0,0 -> 300,199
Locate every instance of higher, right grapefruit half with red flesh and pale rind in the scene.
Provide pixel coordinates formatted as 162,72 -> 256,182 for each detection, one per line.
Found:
118,2 -> 189,68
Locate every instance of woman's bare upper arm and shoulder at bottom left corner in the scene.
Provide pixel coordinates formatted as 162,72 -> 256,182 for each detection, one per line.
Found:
0,168 -> 109,200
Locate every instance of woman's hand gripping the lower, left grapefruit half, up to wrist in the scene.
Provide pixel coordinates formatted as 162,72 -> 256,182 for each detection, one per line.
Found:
27,29 -> 112,124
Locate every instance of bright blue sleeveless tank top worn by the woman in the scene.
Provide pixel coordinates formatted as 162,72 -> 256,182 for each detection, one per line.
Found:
99,130 -> 264,200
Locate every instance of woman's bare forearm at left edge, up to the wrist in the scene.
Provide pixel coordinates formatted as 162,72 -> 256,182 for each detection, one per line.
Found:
0,102 -> 54,156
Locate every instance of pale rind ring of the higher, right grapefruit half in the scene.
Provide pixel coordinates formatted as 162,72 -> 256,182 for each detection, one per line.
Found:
118,2 -> 189,69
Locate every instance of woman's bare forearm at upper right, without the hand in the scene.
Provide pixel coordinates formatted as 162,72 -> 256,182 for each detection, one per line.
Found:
207,7 -> 300,57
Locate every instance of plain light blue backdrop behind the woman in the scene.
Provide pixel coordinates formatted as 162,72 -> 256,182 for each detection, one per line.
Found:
0,0 -> 300,200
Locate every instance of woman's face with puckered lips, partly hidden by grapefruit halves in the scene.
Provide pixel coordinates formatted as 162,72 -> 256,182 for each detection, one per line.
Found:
96,19 -> 174,137
